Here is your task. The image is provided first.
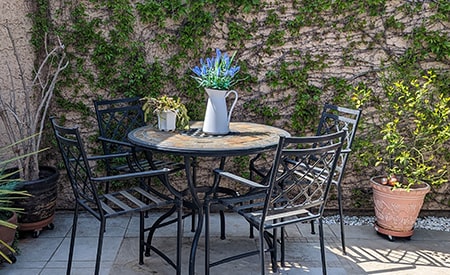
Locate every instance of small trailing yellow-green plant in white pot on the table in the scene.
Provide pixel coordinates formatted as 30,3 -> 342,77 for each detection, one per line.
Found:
142,95 -> 189,131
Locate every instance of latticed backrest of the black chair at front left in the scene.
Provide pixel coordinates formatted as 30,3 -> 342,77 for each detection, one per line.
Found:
50,118 -> 99,205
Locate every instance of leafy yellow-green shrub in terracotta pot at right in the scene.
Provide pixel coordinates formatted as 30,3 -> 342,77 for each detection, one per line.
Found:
360,71 -> 450,240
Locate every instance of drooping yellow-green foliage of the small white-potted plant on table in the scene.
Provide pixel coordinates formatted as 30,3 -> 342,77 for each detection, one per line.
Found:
141,95 -> 189,130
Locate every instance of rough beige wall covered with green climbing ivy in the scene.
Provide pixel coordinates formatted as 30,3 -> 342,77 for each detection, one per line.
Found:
40,0 -> 450,209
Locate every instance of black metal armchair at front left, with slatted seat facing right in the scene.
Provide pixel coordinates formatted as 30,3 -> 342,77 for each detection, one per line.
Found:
51,118 -> 183,274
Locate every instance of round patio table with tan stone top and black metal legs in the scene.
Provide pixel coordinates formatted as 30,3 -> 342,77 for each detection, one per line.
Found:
128,122 -> 290,274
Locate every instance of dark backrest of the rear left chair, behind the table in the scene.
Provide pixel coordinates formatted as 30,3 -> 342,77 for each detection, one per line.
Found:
94,97 -> 145,154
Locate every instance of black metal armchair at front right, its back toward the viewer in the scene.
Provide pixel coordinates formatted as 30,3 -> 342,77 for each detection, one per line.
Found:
205,131 -> 346,274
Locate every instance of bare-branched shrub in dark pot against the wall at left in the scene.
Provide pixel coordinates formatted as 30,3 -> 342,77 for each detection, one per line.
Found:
0,30 -> 68,237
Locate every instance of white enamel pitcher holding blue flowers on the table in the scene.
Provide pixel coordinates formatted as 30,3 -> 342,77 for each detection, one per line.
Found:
192,49 -> 244,135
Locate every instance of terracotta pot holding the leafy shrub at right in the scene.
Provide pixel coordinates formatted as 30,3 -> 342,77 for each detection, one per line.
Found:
370,176 -> 430,237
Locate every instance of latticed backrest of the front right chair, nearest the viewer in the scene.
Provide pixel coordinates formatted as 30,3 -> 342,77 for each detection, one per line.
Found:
262,130 -> 346,226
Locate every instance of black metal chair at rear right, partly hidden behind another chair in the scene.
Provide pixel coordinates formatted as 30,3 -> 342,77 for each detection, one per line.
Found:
250,104 -> 362,254
